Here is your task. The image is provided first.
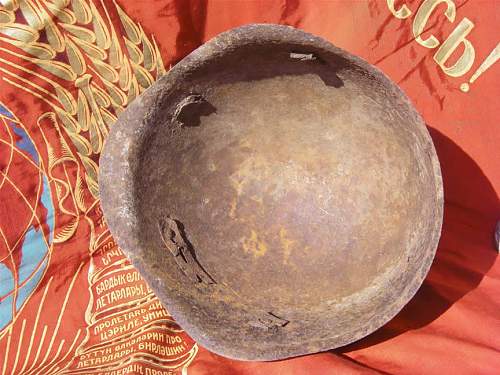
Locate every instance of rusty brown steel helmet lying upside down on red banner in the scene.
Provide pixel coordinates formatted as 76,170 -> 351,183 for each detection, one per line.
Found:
99,25 -> 443,360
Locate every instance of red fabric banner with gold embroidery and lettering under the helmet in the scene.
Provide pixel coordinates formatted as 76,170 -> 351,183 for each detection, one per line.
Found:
0,0 -> 500,375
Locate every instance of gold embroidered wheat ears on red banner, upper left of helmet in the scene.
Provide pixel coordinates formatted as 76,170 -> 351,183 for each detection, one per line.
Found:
0,0 -> 165,201
